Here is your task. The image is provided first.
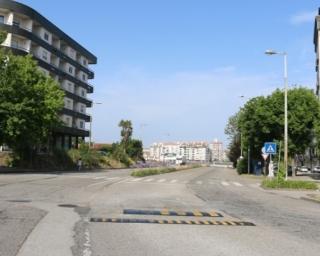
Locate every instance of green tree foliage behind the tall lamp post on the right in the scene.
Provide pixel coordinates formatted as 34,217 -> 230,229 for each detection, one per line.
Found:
226,87 -> 320,166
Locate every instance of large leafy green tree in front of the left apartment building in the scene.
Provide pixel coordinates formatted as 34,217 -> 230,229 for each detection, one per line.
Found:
0,49 -> 64,165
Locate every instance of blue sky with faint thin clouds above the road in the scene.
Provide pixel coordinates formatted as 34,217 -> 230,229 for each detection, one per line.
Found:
19,0 -> 320,147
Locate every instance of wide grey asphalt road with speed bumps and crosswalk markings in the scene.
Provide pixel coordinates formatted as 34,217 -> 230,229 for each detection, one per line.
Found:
0,167 -> 320,256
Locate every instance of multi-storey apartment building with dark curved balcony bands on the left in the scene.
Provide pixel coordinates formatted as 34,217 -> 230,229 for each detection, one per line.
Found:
0,0 -> 97,149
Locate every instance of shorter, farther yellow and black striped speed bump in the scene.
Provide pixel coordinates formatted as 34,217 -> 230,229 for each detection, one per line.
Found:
123,209 -> 223,217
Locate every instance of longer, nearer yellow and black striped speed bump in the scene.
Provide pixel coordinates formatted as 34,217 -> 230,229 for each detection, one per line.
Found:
90,218 -> 255,226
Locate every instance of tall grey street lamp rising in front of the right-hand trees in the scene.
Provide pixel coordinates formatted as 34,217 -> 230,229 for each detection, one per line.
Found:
265,50 -> 288,180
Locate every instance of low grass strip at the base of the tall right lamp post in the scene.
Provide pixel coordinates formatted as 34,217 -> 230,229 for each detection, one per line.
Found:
261,179 -> 318,190
